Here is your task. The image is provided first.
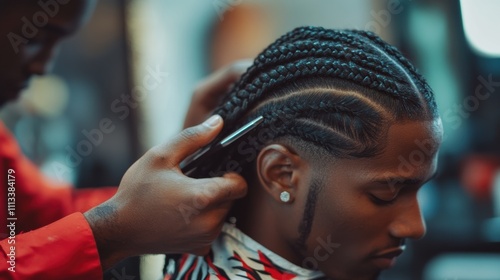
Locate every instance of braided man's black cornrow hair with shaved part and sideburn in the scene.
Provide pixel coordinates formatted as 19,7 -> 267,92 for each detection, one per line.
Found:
197,27 -> 437,248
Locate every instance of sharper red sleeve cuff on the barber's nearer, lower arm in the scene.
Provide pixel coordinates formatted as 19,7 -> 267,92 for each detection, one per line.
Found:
0,213 -> 103,280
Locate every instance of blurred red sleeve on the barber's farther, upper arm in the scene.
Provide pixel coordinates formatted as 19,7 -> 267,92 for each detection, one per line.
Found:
0,122 -> 117,233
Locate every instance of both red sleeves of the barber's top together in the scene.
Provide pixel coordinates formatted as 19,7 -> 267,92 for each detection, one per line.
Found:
0,122 -> 117,279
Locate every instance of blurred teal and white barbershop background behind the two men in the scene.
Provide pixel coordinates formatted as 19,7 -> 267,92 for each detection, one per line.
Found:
0,0 -> 500,279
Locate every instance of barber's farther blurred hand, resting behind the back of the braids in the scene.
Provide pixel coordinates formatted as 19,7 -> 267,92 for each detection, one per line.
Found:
184,60 -> 252,128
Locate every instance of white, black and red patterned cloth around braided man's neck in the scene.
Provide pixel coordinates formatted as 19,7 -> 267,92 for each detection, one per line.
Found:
164,224 -> 326,280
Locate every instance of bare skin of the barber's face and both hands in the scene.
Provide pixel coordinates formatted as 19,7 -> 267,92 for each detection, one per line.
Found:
0,0 -> 248,270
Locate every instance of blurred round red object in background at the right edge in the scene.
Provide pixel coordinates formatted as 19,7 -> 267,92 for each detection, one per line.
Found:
460,155 -> 500,199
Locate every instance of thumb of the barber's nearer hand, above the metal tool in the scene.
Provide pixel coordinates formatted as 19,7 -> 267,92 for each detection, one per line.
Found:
162,115 -> 223,165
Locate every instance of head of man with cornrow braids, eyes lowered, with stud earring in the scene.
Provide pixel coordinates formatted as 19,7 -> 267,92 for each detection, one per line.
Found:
199,27 -> 442,279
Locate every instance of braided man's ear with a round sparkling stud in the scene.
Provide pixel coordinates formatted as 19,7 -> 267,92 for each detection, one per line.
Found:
257,144 -> 305,203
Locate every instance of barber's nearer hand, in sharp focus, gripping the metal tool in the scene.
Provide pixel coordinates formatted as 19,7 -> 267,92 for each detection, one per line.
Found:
84,116 -> 250,269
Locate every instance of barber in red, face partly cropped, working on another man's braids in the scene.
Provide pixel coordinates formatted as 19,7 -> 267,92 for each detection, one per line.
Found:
0,0 -> 250,279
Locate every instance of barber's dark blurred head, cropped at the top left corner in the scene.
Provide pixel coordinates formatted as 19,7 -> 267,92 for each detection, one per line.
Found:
0,0 -> 95,106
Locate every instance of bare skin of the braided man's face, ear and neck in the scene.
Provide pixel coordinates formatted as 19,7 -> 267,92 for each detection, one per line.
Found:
237,119 -> 442,279
